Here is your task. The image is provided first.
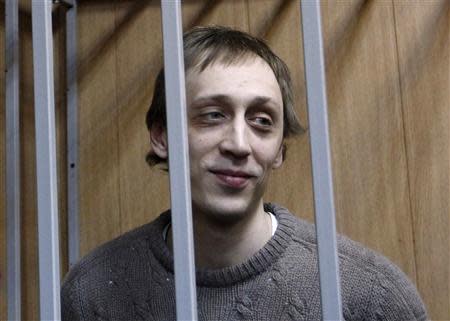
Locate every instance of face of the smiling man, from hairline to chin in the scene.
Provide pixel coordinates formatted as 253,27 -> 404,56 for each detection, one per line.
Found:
186,57 -> 283,221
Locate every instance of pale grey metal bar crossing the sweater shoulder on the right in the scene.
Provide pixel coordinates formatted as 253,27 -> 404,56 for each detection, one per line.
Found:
301,0 -> 342,320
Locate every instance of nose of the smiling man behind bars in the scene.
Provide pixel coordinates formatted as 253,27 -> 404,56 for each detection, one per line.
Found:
219,119 -> 251,158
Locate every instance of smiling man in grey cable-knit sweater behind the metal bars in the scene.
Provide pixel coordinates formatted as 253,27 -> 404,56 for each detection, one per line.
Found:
62,27 -> 427,321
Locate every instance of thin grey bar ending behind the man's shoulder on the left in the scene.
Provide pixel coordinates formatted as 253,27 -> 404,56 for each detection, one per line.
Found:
66,0 -> 80,266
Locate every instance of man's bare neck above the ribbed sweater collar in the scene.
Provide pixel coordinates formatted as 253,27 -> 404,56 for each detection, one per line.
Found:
168,203 -> 272,269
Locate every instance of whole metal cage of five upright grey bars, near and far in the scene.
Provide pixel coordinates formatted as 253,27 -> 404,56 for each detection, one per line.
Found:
5,0 -> 342,320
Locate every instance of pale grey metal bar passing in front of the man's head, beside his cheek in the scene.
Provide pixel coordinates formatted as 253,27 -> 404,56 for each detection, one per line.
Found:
161,0 -> 197,321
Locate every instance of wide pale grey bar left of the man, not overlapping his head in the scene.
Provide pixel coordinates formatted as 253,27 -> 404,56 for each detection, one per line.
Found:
32,0 -> 61,320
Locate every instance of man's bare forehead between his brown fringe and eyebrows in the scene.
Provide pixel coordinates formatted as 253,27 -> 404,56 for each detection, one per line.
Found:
186,57 -> 282,105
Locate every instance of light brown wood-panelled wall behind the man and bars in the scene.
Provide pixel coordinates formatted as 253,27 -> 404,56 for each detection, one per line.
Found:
0,0 -> 450,320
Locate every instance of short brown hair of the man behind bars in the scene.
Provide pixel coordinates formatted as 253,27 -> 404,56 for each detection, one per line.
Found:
146,26 -> 304,165
